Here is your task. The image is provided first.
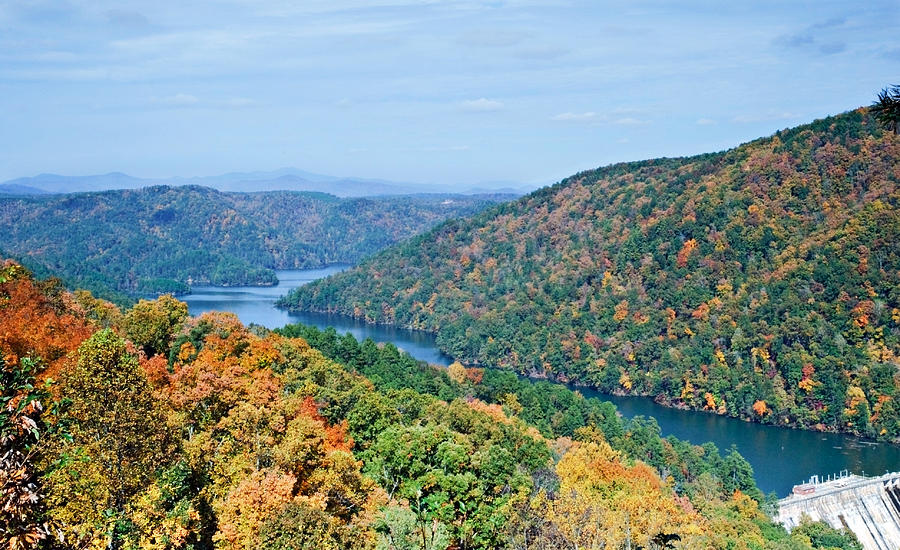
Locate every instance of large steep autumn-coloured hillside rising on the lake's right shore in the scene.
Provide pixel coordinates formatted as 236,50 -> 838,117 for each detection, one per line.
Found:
282,109 -> 900,440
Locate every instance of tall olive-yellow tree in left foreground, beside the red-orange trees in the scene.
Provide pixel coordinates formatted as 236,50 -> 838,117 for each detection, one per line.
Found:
46,329 -> 173,548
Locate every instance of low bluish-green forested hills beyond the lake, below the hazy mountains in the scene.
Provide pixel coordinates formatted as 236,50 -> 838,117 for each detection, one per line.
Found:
0,186 -> 502,302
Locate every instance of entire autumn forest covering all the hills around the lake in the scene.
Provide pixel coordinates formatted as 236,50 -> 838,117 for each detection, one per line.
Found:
0,108 -> 900,550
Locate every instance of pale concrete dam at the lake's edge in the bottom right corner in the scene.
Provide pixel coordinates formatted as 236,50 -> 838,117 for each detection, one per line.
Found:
775,472 -> 900,550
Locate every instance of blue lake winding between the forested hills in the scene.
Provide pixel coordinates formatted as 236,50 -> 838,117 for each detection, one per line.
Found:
180,265 -> 900,496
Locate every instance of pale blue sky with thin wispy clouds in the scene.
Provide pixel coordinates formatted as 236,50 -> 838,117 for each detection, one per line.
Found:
0,0 -> 900,186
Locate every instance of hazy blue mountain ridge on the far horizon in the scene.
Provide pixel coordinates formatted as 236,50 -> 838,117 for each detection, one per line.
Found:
0,168 -> 536,201
